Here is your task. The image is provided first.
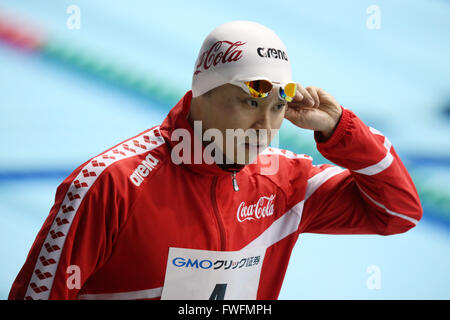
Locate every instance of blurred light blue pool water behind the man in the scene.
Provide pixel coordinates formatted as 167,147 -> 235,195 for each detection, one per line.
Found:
0,0 -> 450,299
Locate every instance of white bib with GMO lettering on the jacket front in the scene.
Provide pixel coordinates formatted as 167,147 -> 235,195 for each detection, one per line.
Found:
161,248 -> 266,300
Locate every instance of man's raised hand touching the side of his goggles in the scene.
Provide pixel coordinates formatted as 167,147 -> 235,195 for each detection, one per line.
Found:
284,83 -> 342,139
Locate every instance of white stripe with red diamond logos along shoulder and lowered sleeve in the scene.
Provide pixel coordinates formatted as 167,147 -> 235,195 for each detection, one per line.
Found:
21,127 -> 164,300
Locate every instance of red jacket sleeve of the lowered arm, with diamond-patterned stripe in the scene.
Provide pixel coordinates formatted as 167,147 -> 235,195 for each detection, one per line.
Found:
9,162 -> 125,300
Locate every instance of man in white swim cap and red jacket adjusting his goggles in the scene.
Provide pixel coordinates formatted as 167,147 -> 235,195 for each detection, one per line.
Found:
9,21 -> 422,299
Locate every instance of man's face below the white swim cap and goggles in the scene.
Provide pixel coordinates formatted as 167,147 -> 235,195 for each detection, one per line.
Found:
191,84 -> 287,164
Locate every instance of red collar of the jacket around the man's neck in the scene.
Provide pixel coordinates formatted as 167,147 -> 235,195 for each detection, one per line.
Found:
160,90 -> 245,176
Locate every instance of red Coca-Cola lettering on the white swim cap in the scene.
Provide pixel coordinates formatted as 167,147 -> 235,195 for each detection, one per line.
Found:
194,40 -> 246,75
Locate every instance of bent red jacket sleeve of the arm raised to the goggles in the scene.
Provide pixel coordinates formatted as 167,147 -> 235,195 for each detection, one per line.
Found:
299,108 -> 422,235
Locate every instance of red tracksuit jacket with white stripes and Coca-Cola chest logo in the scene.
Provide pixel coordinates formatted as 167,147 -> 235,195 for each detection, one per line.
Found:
9,91 -> 422,299
